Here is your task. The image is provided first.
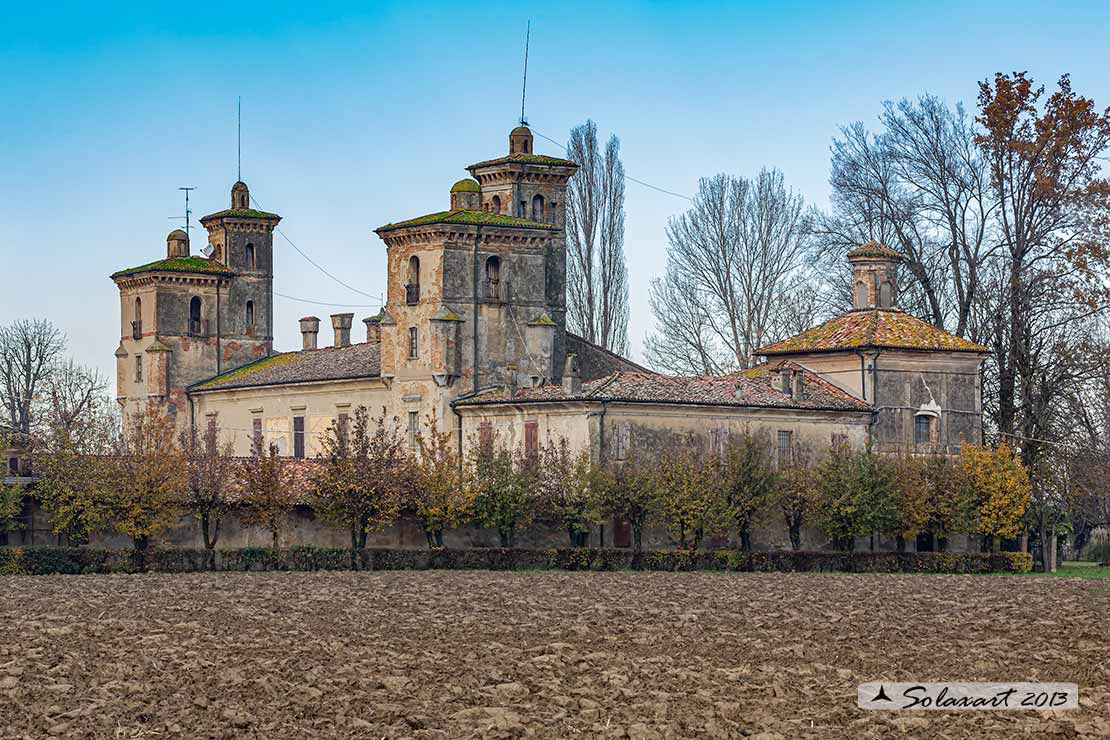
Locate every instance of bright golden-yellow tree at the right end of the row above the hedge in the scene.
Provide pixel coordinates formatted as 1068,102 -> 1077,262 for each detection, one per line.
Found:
960,442 -> 1030,550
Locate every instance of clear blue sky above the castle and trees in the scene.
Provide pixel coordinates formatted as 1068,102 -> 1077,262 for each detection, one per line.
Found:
0,0 -> 1110,378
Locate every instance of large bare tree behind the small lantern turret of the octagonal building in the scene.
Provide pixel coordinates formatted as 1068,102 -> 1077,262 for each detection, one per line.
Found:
816,95 -> 998,336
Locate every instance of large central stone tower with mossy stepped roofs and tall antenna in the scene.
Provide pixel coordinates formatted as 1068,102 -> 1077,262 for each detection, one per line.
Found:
375,126 -> 577,426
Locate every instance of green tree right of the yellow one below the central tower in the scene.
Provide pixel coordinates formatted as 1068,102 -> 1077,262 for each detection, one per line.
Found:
471,440 -> 539,547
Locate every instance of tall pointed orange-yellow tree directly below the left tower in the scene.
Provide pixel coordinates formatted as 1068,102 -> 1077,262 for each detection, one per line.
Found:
111,404 -> 189,557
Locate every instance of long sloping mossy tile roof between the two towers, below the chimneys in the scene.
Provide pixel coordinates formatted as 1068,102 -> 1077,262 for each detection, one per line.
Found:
190,342 -> 382,391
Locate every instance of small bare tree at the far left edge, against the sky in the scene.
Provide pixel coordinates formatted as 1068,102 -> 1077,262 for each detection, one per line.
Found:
0,318 -> 65,434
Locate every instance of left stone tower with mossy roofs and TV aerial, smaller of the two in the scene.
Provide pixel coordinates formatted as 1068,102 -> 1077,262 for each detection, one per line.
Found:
112,182 -> 280,424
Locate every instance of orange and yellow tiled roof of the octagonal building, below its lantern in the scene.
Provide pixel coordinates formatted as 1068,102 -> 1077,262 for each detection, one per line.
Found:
757,308 -> 990,355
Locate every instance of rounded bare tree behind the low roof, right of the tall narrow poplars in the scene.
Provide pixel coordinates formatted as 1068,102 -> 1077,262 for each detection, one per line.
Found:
647,170 -> 810,374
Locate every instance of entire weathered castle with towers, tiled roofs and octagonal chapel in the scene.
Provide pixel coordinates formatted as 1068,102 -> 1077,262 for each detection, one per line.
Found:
112,125 -> 988,544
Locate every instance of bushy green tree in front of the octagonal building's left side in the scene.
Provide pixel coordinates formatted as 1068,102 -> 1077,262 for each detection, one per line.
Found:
815,445 -> 897,550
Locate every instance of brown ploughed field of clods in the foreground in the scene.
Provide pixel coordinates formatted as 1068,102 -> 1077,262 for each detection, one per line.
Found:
0,571 -> 1110,740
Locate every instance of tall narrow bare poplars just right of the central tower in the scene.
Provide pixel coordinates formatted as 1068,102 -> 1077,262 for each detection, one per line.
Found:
566,121 -> 628,354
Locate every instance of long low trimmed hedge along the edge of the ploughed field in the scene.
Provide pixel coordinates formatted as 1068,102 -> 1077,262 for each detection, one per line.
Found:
0,547 -> 1032,576
